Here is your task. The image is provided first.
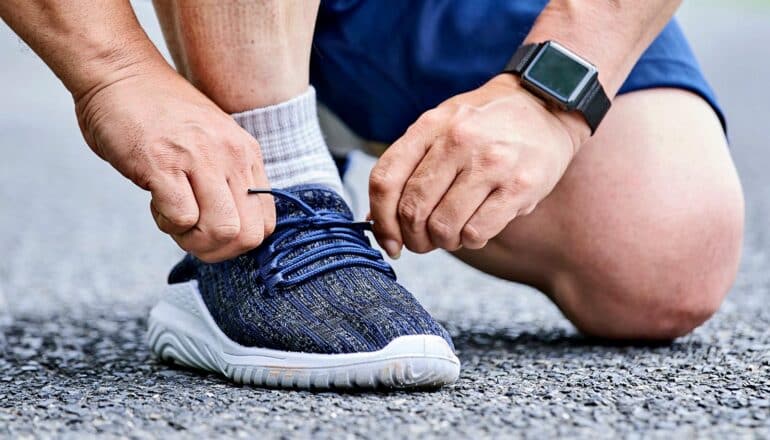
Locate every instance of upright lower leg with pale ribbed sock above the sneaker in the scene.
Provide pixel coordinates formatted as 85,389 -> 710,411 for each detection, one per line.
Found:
154,0 -> 342,192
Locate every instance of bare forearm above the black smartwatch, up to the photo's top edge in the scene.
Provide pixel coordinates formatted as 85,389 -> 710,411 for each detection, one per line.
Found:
526,0 -> 681,96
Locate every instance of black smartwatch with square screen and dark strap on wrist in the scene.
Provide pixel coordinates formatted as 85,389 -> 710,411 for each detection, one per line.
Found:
505,41 -> 611,134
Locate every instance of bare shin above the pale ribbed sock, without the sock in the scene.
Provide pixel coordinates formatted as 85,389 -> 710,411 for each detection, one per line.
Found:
153,0 -> 319,113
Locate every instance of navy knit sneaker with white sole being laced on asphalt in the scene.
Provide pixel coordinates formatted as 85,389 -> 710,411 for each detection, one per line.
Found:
149,185 -> 460,388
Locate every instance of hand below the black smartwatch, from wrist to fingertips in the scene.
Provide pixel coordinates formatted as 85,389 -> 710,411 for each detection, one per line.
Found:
369,74 -> 590,257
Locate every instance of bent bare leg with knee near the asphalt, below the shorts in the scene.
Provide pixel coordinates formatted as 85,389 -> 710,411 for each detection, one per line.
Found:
457,89 -> 743,339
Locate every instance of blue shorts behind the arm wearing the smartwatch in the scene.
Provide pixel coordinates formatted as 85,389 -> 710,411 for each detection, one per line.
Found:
311,0 -> 725,142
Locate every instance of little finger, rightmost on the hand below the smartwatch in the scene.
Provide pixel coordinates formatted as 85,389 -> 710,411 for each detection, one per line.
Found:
461,188 -> 523,249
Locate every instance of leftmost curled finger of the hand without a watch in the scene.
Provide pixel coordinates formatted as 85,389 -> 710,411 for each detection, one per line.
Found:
149,173 -> 199,234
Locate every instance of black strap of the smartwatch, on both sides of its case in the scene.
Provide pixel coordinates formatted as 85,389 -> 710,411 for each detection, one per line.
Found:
504,43 -> 612,134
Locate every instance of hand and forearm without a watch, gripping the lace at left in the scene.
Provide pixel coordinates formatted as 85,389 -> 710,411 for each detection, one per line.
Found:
0,0 -> 275,262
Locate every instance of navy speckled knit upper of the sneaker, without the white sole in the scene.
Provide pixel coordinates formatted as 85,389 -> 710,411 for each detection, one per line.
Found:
169,185 -> 452,354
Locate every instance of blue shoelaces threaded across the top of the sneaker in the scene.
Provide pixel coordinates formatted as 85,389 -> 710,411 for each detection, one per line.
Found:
249,188 -> 396,292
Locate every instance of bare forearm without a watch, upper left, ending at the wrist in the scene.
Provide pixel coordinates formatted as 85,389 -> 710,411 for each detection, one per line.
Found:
0,0 -> 171,100
